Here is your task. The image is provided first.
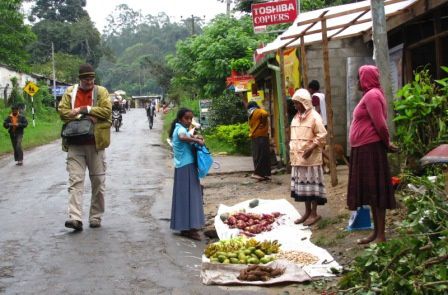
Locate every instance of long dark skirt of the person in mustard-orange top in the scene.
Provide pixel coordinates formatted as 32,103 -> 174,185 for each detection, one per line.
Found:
252,136 -> 271,177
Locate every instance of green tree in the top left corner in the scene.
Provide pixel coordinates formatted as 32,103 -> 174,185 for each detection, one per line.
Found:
0,0 -> 36,71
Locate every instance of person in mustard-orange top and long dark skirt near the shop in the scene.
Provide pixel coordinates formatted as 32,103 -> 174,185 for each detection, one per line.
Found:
247,100 -> 271,180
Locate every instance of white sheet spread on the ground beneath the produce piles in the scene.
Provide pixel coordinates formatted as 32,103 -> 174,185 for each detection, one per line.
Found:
212,199 -> 341,277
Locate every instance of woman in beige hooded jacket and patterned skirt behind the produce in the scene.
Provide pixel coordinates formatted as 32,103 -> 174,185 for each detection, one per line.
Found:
289,88 -> 327,225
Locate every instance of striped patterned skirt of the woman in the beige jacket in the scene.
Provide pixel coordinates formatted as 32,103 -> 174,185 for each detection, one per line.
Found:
291,165 -> 327,205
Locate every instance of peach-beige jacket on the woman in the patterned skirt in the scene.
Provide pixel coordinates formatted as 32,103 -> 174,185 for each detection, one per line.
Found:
289,109 -> 327,166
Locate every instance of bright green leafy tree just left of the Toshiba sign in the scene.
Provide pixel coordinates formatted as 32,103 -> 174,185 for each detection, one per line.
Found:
167,15 -> 266,98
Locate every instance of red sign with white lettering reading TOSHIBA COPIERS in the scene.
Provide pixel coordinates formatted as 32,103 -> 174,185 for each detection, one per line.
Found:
252,0 -> 297,27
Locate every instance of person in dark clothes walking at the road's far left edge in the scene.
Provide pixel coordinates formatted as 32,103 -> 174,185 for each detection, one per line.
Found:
3,104 -> 28,166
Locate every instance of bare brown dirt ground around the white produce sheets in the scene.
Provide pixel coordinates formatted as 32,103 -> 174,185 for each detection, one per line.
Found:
202,165 -> 400,294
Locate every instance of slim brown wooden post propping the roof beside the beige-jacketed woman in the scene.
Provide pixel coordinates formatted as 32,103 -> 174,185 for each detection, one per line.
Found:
321,18 -> 338,186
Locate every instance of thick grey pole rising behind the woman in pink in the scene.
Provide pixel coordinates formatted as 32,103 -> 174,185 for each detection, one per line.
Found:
370,0 -> 395,138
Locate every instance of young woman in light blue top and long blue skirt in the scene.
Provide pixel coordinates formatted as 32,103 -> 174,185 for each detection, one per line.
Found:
169,108 -> 205,241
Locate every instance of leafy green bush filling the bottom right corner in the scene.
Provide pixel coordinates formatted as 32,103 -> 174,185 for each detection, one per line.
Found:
340,176 -> 448,295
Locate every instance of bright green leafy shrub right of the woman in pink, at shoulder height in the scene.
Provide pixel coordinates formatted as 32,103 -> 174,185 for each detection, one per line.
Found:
394,67 -> 448,167
